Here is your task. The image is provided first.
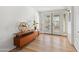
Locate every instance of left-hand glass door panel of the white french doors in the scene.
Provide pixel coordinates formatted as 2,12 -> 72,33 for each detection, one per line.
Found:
40,12 -> 51,34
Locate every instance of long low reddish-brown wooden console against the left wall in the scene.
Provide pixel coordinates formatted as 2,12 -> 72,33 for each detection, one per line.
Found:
14,31 -> 39,48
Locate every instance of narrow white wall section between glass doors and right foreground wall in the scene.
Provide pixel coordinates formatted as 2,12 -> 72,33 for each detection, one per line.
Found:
66,6 -> 73,44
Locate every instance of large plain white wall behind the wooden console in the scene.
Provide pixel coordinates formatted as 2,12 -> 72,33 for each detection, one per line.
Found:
0,7 -> 37,51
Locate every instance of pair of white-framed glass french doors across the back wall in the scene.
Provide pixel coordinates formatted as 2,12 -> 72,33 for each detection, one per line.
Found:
40,12 -> 66,35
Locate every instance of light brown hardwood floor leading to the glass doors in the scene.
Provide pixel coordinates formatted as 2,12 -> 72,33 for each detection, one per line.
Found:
12,34 -> 76,52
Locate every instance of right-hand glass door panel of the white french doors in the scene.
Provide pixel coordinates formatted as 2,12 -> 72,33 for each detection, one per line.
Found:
52,15 -> 60,34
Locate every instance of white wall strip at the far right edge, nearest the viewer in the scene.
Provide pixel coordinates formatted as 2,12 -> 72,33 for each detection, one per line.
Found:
74,6 -> 79,51
